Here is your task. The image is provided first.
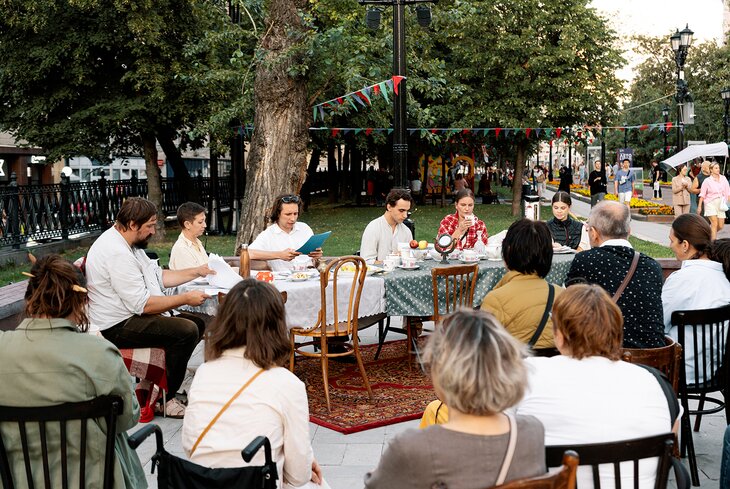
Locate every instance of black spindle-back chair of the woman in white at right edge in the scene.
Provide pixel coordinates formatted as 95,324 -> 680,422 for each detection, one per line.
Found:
672,305 -> 730,486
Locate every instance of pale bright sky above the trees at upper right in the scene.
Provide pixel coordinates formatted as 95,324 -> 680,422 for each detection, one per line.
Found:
591,0 -> 723,81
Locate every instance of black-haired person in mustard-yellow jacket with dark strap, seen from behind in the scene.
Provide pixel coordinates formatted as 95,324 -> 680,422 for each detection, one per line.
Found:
482,219 -> 563,349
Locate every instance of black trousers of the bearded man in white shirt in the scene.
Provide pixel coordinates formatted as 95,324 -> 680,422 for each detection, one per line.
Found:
101,313 -> 205,396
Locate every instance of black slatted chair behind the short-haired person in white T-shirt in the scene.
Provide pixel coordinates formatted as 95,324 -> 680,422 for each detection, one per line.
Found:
545,433 -> 690,489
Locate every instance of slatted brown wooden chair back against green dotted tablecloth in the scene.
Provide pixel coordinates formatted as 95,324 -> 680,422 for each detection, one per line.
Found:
431,263 -> 479,321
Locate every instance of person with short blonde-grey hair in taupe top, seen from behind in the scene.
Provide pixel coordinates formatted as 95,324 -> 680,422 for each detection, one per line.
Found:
365,310 -> 545,489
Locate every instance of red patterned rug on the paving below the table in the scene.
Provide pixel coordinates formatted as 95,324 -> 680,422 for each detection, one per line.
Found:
294,340 -> 436,434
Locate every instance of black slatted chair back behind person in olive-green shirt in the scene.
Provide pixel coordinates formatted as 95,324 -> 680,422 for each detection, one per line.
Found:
0,396 -> 123,489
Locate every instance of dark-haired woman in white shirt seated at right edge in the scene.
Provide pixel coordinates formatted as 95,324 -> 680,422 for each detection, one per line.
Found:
662,214 -> 730,384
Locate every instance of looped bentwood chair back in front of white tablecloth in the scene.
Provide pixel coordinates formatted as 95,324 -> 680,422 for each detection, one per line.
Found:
318,255 -> 368,336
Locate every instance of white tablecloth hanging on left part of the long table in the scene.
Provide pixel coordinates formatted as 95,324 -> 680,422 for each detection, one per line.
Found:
178,276 -> 385,328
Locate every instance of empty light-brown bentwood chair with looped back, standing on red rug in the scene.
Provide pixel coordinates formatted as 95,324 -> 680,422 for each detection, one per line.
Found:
289,256 -> 373,410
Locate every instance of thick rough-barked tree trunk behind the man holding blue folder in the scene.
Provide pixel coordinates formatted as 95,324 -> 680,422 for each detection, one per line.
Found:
236,0 -> 311,250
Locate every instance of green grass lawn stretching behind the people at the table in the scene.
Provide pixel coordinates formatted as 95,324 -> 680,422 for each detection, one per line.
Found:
0,197 -> 673,284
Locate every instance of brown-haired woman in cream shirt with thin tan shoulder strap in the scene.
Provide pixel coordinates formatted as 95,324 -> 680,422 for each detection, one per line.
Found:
182,279 -> 329,488
